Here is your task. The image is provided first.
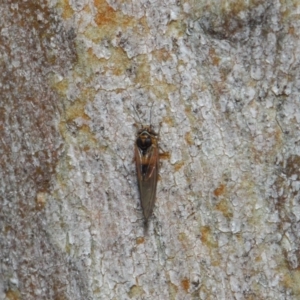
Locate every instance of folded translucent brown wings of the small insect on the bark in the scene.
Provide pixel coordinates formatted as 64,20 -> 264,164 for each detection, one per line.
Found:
135,144 -> 158,221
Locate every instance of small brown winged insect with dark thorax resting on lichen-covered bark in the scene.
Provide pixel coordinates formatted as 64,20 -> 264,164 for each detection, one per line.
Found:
135,106 -> 159,223
